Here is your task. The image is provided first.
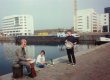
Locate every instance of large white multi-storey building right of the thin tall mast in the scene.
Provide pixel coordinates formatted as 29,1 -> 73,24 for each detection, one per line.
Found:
74,8 -> 98,32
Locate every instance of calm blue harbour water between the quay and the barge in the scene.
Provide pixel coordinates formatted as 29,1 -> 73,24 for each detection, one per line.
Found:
0,43 -> 94,75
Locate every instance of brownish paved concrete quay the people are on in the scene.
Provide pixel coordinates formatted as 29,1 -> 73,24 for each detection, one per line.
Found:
0,43 -> 110,80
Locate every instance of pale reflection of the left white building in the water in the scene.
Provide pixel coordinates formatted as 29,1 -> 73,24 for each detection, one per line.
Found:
2,43 -> 35,62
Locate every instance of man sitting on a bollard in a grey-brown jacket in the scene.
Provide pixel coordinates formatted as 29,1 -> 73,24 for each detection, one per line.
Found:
16,39 -> 32,75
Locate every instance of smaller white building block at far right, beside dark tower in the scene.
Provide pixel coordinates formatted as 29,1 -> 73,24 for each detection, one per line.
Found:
99,13 -> 110,32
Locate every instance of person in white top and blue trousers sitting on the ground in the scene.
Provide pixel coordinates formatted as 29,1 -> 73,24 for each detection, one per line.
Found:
36,50 -> 47,68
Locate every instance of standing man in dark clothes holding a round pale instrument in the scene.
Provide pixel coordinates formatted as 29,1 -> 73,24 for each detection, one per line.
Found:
65,31 -> 76,65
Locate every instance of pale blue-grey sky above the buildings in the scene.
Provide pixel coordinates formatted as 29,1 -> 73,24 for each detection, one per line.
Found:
0,0 -> 110,30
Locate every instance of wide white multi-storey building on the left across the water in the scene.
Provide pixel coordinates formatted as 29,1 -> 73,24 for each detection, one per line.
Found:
2,15 -> 34,36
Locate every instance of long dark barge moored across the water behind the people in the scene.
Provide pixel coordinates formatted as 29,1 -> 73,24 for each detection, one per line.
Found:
15,33 -> 79,44
